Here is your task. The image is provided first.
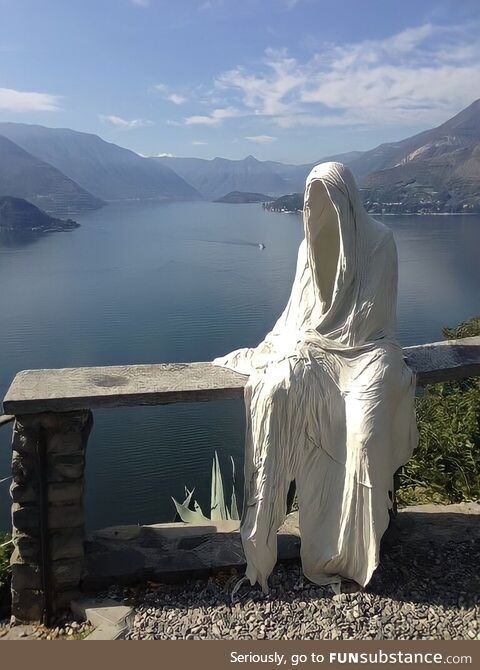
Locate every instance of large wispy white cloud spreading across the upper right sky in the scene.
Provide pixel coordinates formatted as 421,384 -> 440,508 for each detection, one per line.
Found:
211,23 -> 480,128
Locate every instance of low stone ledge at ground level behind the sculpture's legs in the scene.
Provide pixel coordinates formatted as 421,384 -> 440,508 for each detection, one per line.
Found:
83,503 -> 480,591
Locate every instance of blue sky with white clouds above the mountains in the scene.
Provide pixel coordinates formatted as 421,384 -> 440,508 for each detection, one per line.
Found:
0,0 -> 480,163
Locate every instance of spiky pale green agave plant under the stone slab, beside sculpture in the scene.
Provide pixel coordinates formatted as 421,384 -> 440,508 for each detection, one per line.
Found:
172,452 -> 240,526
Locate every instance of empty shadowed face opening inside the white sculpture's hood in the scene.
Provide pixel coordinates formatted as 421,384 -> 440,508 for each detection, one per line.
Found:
305,179 -> 340,311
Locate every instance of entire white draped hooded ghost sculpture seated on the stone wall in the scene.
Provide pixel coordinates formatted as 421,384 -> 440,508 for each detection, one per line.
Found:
214,163 -> 417,591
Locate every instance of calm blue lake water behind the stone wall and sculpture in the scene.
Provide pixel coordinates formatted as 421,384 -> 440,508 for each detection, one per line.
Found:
0,203 -> 480,528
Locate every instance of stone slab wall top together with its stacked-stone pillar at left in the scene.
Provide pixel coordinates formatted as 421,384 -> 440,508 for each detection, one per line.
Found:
0,337 -> 480,621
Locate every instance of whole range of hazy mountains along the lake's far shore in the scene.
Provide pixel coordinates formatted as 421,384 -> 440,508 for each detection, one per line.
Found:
0,100 -> 480,213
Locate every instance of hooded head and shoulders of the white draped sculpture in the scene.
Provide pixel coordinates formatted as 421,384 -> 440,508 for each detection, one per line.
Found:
292,162 -> 397,346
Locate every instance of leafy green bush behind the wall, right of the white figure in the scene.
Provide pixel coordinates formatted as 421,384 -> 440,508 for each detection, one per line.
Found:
397,317 -> 480,505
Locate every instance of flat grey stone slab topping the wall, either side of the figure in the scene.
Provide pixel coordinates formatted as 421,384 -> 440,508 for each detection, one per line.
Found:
3,337 -> 480,414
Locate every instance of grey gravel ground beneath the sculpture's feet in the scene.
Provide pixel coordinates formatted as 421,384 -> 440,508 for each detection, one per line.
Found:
124,539 -> 480,640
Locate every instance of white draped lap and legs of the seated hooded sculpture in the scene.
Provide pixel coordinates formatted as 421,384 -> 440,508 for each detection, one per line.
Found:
242,347 -> 408,584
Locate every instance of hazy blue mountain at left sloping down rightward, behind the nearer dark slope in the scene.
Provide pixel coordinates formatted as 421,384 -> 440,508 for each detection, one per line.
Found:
0,123 -> 201,201
